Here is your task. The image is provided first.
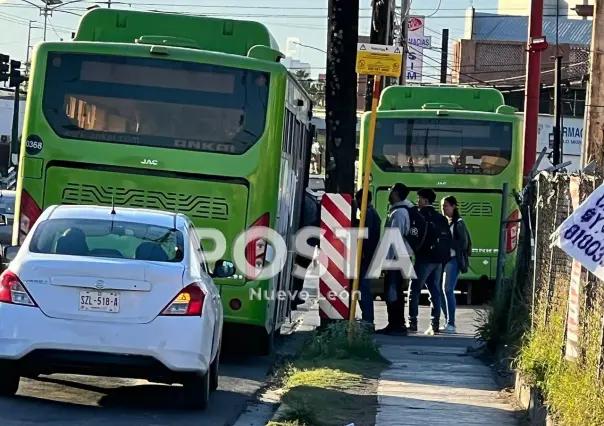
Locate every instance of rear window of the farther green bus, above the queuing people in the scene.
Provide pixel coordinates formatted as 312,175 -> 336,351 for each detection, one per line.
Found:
373,118 -> 513,175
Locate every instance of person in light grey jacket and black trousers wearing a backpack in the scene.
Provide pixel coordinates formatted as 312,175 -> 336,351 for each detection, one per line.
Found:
377,183 -> 427,336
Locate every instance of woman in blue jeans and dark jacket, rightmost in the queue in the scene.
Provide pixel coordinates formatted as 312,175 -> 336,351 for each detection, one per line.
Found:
441,195 -> 471,334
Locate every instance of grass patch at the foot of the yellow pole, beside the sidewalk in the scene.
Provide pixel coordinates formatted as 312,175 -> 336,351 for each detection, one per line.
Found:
269,322 -> 388,426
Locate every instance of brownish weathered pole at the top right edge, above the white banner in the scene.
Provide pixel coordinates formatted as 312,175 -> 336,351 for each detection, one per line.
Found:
581,0 -> 604,173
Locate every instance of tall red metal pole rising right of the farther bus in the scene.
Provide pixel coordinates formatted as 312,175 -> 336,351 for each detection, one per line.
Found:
524,0 -> 547,176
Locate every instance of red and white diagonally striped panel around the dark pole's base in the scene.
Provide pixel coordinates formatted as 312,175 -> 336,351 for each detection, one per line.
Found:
319,194 -> 352,320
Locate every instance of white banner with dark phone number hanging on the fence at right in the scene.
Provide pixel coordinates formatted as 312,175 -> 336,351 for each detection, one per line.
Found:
553,185 -> 604,280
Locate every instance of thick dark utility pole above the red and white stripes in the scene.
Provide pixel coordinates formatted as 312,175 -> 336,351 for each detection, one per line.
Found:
325,0 -> 359,194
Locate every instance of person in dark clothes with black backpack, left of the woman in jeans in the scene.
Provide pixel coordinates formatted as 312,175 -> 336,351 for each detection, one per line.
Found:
409,188 -> 452,335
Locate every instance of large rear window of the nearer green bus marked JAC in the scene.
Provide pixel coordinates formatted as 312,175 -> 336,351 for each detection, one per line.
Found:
43,52 -> 270,154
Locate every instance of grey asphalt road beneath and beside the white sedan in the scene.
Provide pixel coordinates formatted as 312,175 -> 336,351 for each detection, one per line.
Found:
0,286 -> 316,426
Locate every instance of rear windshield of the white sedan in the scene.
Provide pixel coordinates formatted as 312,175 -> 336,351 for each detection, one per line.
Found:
29,219 -> 184,262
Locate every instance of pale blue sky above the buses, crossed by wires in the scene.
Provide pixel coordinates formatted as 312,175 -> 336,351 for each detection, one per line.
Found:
0,0 -> 497,81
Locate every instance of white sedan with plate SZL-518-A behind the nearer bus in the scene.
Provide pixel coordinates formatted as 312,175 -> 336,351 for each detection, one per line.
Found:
0,206 -> 229,409
